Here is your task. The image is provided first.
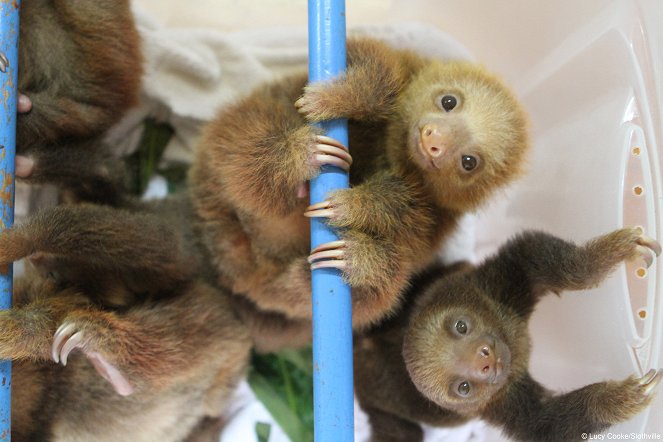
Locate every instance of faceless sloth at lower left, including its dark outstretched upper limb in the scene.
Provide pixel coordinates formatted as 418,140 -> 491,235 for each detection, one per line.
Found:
0,198 -> 252,441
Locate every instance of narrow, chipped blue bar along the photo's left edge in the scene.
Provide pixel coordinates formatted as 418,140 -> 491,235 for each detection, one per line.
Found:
0,0 -> 20,441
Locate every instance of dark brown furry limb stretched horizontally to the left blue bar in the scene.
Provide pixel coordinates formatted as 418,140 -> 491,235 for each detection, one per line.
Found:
0,197 -> 205,307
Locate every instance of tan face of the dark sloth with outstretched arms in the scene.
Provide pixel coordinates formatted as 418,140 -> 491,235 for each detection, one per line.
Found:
403,282 -> 521,416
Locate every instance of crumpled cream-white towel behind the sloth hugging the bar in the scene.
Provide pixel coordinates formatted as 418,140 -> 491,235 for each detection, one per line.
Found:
109,5 -> 471,169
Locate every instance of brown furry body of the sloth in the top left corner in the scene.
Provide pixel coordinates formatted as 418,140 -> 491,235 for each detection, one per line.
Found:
16,0 -> 143,202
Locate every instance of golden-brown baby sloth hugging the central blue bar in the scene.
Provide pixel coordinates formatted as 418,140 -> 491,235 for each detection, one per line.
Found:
191,38 -> 528,348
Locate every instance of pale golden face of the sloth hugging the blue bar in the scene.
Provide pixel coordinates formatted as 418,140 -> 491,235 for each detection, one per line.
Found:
398,62 -> 529,210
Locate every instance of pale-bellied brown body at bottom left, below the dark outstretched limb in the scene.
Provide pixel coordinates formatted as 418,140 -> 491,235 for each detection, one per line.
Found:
5,278 -> 251,441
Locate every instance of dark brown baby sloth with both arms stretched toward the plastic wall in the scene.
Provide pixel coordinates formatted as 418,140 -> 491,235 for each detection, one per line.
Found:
355,228 -> 663,442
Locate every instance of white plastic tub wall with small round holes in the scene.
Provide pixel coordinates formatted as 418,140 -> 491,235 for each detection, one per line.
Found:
470,1 -> 663,437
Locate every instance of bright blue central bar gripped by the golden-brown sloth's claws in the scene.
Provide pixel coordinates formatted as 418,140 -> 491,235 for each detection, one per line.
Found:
308,0 -> 354,442
